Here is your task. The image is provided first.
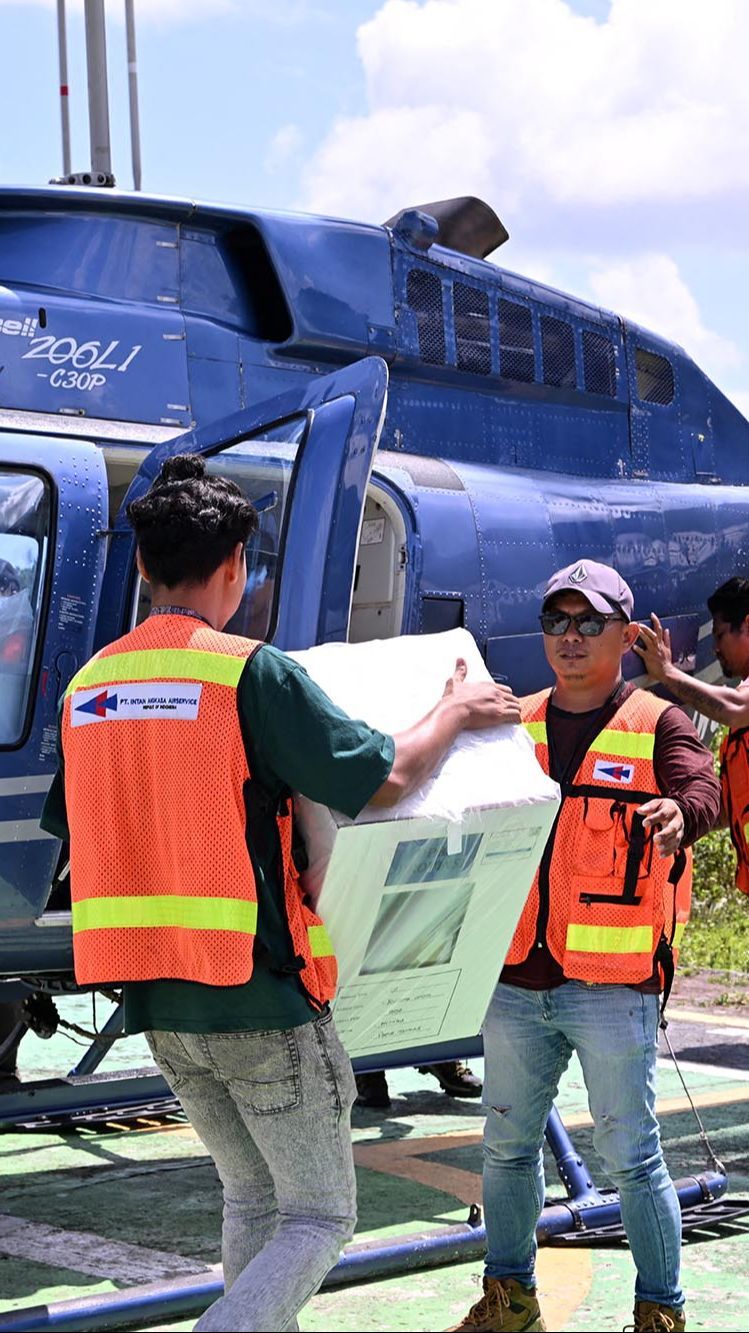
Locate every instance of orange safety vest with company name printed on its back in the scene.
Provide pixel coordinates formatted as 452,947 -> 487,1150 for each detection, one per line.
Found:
63,615 -> 337,1005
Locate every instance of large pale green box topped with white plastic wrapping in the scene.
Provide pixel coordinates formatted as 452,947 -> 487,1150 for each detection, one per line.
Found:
292,629 -> 558,1056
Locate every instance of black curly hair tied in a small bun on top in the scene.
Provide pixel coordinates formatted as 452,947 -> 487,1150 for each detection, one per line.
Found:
127,453 -> 257,588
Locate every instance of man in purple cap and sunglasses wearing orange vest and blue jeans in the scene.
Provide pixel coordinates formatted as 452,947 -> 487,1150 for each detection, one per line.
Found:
447,560 -> 720,1333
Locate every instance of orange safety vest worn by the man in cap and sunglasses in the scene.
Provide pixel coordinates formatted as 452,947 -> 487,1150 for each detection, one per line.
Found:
506,689 -> 692,985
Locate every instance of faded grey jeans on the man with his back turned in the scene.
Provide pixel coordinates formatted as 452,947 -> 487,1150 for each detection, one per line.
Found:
145,1013 -> 356,1333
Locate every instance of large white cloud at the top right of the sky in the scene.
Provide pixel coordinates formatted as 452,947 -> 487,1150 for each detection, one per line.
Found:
297,0 -> 749,233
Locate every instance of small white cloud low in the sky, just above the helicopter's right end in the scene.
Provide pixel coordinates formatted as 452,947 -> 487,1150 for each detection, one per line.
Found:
589,255 -> 742,373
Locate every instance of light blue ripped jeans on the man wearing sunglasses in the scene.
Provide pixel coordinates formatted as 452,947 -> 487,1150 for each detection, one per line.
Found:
482,981 -> 684,1308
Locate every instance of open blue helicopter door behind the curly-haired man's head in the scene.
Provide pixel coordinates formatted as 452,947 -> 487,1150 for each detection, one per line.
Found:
99,357 -> 388,651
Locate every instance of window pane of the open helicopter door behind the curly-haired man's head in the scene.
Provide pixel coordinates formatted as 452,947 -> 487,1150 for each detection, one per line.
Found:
136,416 -> 307,639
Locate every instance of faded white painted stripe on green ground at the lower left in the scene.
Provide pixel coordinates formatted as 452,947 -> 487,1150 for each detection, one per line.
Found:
0,1213 -> 219,1284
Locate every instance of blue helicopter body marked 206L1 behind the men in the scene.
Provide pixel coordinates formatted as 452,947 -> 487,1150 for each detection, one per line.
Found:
0,188 -> 749,977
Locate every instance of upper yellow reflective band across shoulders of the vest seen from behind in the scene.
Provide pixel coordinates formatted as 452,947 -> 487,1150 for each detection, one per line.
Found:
65,648 -> 247,694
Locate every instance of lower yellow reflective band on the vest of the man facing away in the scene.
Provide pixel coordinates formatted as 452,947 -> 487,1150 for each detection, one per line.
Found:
73,893 -> 257,934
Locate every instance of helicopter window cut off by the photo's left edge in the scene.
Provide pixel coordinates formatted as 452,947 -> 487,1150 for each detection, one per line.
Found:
0,469 -> 49,745
